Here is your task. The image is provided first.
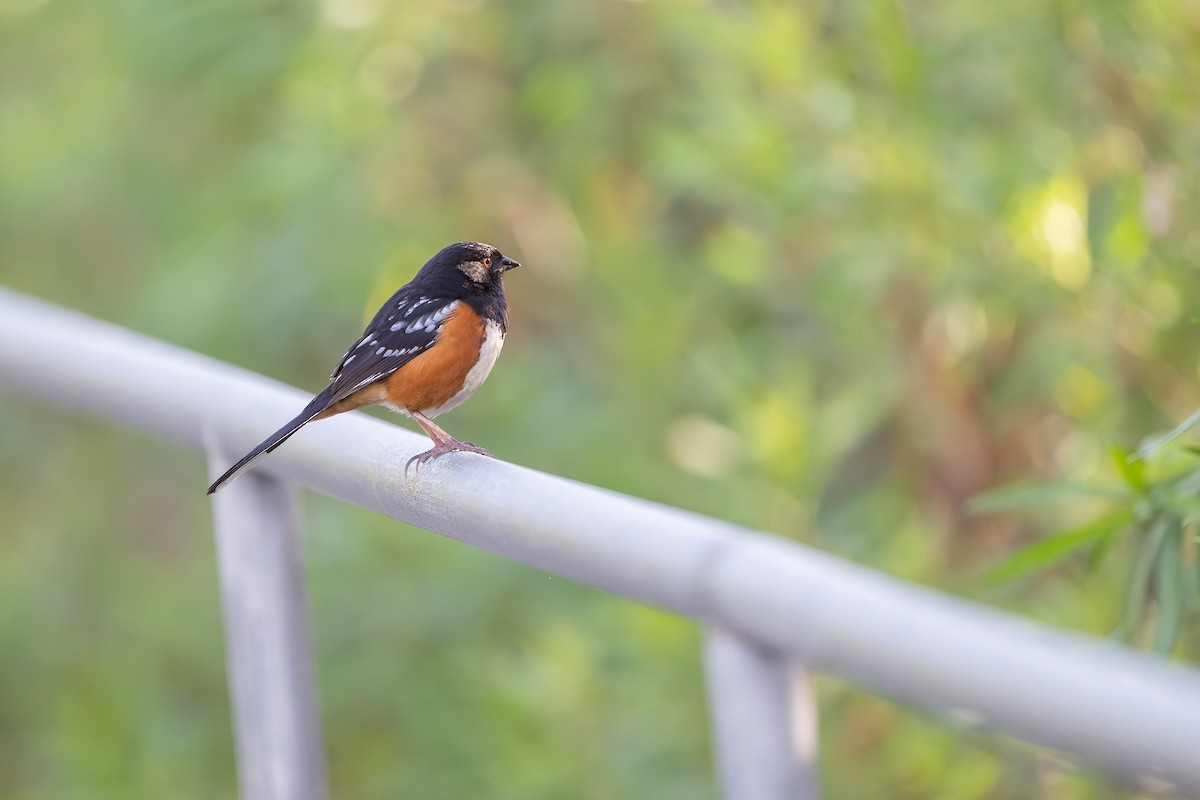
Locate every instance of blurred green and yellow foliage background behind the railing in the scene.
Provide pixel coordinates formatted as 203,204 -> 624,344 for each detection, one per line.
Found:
0,0 -> 1200,800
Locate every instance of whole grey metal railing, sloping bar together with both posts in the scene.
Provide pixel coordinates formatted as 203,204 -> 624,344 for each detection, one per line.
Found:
0,289 -> 1200,800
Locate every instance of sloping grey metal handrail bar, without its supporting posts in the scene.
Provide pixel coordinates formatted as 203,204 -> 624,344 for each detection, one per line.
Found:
0,284 -> 1200,794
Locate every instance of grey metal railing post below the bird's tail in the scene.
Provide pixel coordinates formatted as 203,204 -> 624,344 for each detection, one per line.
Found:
209,450 -> 329,800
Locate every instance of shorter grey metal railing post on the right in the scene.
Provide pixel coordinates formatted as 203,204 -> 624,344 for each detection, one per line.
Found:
704,627 -> 817,800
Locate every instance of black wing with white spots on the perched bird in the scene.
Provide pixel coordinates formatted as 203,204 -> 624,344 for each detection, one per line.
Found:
329,285 -> 460,403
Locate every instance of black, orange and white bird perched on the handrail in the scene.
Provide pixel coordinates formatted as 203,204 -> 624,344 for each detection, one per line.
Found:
208,241 -> 521,494
